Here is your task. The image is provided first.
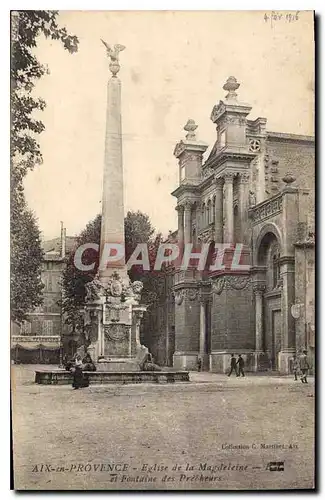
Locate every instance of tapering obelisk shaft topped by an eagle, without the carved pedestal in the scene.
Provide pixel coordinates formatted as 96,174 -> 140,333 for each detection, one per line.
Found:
99,40 -> 127,284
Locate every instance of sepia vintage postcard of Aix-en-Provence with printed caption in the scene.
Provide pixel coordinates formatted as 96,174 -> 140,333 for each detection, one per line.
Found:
11,10 -> 315,491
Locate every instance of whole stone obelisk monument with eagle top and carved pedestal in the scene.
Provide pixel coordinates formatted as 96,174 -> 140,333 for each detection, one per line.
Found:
84,44 -> 146,372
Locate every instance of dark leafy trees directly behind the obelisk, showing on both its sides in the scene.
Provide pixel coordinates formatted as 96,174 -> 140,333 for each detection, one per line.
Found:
62,211 -> 165,330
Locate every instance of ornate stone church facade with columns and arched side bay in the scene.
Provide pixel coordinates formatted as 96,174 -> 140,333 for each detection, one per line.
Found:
145,77 -> 315,373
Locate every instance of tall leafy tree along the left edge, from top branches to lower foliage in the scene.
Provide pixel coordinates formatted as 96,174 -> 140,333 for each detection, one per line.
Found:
10,10 -> 78,322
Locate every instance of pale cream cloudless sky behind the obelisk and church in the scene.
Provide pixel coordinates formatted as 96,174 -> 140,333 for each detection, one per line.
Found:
25,11 -> 314,239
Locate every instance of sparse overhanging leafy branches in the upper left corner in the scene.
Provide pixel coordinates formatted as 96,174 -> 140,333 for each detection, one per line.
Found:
11,10 -> 78,195
